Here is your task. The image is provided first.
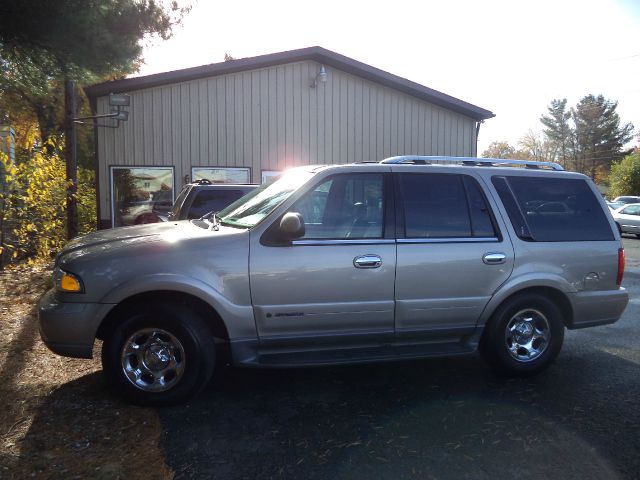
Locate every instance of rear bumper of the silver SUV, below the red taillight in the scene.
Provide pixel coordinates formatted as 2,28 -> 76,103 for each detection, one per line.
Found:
568,288 -> 629,330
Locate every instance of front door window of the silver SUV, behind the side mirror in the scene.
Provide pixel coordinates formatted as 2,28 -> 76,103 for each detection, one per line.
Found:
289,173 -> 384,240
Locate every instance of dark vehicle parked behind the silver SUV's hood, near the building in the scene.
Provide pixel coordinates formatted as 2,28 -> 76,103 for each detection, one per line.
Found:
168,180 -> 258,222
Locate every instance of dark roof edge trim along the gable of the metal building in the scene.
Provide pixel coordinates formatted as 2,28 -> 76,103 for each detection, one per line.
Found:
84,47 -> 495,121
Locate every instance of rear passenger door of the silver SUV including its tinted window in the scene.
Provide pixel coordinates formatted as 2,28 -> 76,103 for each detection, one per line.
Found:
395,171 -> 513,338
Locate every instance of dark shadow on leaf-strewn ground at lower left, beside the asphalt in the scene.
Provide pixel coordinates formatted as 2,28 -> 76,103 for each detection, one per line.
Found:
5,372 -> 170,479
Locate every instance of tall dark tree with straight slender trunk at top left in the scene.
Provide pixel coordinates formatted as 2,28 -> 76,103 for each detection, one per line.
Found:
0,0 -> 188,237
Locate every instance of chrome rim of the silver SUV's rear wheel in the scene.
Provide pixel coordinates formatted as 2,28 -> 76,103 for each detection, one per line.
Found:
505,308 -> 551,363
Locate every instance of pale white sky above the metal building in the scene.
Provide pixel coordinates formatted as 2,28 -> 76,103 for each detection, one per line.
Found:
135,0 -> 640,154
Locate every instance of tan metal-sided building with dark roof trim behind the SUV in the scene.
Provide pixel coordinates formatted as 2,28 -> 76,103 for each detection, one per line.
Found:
86,47 -> 493,227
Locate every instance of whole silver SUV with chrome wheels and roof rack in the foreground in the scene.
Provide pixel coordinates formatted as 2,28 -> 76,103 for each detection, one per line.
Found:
39,156 -> 628,405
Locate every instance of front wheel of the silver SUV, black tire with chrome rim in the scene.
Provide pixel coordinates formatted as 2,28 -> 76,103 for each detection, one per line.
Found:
102,303 -> 215,406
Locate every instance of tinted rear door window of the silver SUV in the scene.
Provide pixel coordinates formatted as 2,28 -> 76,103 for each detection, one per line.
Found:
400,173 -> 496,238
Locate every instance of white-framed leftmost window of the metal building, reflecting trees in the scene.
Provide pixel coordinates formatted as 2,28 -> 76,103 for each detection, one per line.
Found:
111,167 -> 173,227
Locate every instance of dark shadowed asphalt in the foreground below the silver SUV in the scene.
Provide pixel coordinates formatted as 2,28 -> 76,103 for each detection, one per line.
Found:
160,349 -> 640,479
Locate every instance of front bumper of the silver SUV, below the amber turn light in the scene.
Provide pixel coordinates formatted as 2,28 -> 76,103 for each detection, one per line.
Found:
38,290 -> 114,358
